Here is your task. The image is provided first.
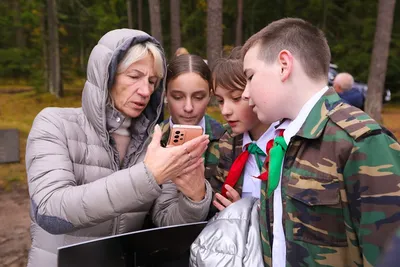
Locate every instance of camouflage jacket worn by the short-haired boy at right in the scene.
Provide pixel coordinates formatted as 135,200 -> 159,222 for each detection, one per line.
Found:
264,88 -> 400,267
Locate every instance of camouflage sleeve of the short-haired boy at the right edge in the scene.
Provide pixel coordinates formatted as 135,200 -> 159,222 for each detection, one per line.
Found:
342,133 -> 400,266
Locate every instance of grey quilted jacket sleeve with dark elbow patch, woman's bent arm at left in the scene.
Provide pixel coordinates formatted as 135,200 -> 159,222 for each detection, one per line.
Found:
26,108 -> 161,234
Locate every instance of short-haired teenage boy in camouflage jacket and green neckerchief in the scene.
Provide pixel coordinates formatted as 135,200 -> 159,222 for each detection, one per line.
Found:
242,18 -> 400,267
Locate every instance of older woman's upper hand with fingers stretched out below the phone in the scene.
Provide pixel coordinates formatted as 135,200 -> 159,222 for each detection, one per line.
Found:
144,125 -> 209,184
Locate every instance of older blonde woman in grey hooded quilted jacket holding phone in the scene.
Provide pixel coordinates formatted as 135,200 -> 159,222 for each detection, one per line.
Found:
26,29 -> 211,267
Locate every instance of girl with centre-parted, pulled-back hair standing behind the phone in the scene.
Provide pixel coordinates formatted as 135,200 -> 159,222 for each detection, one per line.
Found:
161,55 -> 225,180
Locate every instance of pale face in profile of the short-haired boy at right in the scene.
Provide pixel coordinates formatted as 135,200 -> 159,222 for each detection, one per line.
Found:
243,45 -> 287,124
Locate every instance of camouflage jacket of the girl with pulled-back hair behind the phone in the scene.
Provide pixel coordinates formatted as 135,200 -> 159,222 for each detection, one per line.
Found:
160,115 -> 226,180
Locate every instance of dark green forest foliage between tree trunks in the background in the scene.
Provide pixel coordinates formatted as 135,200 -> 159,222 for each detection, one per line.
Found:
0,0 -> 400,94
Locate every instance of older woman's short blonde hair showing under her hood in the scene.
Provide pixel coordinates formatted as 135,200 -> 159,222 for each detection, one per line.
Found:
117,42 -> 164,79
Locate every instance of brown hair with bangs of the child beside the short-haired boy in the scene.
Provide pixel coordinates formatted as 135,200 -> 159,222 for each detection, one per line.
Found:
212,47 -> 246,91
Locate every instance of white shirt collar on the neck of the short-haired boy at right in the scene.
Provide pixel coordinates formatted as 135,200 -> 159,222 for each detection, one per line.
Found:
283,86 -> 329,144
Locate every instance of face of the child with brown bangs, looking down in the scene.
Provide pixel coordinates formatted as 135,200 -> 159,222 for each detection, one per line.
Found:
214,86 -> 260,134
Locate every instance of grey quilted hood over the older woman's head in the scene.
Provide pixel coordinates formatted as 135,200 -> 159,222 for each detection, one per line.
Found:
82,29 -> 166,142
